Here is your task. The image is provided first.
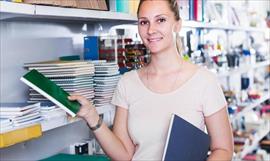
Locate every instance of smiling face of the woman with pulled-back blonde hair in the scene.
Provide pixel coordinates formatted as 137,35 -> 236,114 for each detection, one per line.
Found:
138,0 -> 180,53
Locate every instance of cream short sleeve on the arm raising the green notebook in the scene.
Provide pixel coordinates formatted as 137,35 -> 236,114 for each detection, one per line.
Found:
111,76 -> 128,109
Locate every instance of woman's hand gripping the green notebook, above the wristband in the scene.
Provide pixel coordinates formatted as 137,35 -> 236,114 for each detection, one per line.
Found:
68,95 -> 99,127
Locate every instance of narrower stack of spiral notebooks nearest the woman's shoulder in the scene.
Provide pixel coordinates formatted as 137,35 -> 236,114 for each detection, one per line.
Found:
93,60 -> 120,107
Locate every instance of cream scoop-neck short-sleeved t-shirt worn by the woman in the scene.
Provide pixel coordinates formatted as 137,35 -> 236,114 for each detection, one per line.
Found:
112,68 -> 226,161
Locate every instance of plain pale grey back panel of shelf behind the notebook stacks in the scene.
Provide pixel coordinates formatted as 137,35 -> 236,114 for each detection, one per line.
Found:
0,20 -> 99,102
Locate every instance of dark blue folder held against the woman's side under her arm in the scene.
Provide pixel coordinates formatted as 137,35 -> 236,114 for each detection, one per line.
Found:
162,114 -> 210,161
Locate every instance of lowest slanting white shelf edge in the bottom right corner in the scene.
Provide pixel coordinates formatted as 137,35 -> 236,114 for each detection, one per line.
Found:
238,120 -> 270,159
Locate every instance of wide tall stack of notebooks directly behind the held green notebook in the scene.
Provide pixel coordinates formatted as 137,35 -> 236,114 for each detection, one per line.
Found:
25,60 -> 95,102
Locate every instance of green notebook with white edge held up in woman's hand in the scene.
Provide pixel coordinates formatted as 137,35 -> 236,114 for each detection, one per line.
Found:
21,69 -> 81,117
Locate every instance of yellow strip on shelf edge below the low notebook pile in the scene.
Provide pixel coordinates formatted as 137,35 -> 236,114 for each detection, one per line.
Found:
0,124 -> 42,148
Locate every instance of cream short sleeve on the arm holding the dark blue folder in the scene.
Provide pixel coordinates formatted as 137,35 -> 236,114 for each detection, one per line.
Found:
202,75 -> 227,117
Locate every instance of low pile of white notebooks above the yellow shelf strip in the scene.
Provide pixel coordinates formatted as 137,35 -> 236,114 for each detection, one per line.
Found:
0,103 -> 43,133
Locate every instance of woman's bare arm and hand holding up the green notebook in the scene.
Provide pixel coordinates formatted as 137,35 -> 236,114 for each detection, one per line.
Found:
70,95 -> 135,160
